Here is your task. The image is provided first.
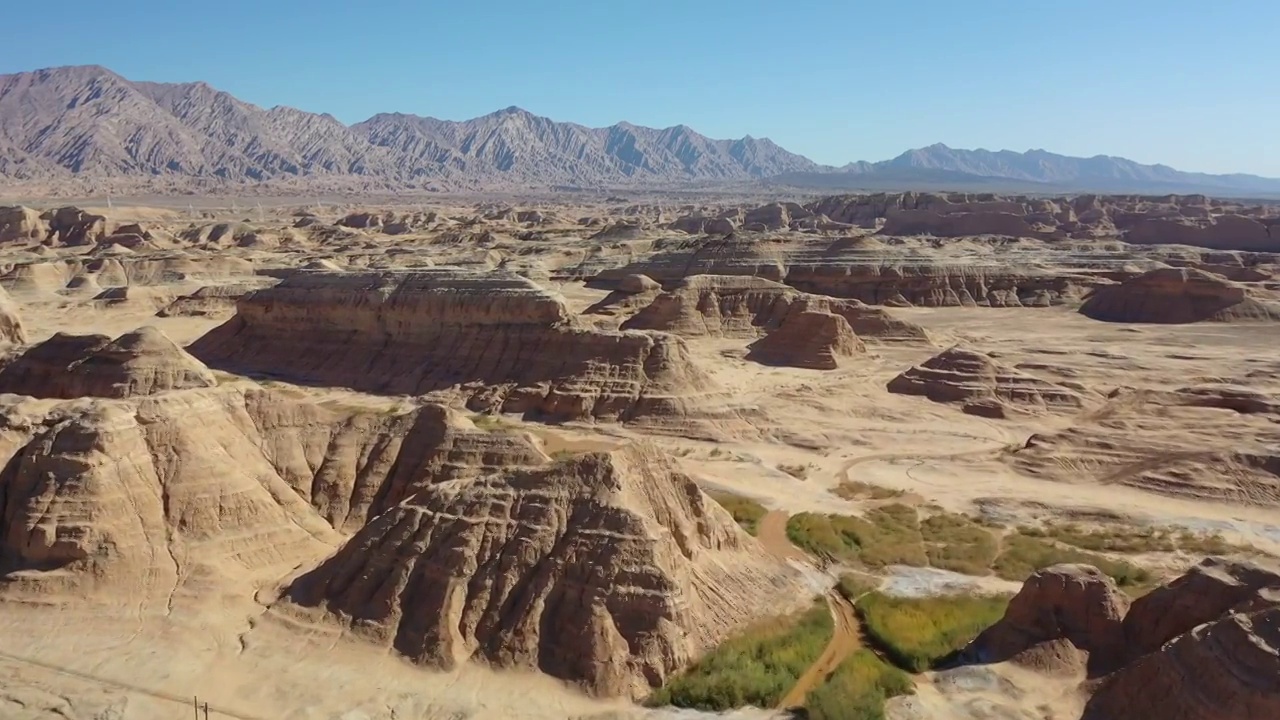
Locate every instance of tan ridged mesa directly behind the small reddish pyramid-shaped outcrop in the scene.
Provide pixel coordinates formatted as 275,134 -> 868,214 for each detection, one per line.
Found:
622,275 -> 928,342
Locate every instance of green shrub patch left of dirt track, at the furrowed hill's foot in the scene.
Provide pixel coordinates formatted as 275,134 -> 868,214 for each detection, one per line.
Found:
645,601 -> 833,712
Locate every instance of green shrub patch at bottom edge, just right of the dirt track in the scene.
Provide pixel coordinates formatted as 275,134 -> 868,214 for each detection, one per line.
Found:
804,650 -> 915,720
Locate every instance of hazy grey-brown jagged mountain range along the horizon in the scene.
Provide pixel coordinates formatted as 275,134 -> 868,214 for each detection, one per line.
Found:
0,65 -> 1280,195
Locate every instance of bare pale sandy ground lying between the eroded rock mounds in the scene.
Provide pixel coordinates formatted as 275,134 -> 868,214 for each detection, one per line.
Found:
0,202 -> 1280,720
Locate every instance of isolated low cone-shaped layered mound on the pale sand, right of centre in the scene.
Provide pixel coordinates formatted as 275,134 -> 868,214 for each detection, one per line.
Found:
888,346 -> 1083,418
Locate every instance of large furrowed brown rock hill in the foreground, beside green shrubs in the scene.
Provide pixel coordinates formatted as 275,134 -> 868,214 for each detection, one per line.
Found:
276,446 -> 804,696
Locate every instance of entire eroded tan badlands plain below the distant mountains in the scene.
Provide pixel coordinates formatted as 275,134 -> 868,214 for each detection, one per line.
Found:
0,192 -> 1280,720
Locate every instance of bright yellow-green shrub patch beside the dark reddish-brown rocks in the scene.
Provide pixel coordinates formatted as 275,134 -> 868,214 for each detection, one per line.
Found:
856,592 -> 1009,673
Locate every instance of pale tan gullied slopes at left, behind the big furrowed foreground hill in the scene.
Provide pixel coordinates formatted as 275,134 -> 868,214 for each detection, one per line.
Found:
0,383 -> 545,598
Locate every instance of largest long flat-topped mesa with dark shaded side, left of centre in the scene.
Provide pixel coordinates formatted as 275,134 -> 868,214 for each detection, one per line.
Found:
189,268 -> 732,420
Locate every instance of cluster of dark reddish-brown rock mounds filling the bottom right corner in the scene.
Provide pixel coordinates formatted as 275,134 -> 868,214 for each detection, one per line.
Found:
964,559 -> 1280,720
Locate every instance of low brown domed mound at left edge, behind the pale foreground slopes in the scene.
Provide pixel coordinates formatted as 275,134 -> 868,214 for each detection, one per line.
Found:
0,325 -> 218,398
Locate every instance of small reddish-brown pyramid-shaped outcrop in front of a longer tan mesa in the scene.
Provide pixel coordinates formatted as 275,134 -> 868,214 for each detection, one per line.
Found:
746,305 -> 867,370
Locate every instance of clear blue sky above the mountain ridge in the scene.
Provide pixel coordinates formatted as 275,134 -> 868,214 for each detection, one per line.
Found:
0,0 -> 1280,177
